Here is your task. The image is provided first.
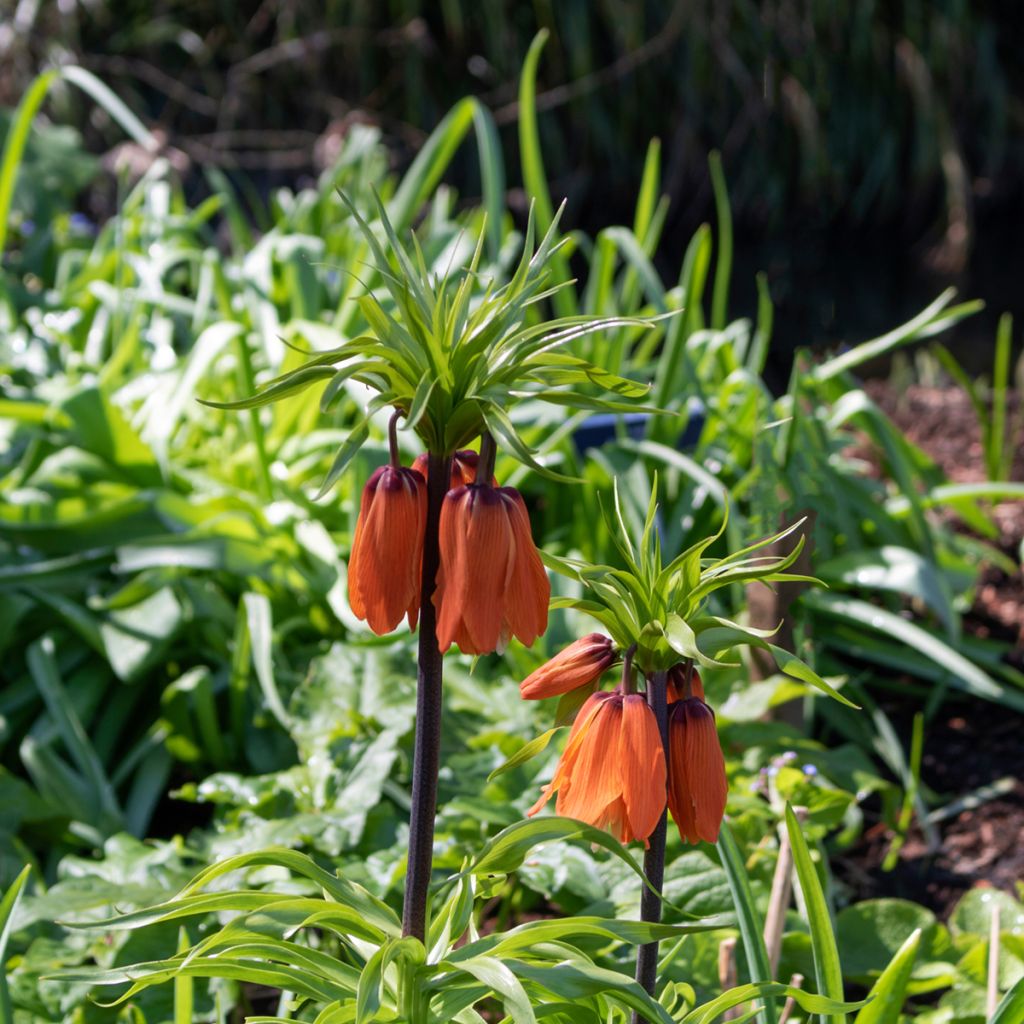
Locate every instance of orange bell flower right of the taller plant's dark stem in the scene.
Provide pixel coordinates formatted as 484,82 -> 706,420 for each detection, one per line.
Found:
434,483 -> 551,654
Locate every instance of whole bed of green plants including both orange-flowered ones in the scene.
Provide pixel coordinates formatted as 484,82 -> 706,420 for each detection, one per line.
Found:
0,25 -> 1024,1024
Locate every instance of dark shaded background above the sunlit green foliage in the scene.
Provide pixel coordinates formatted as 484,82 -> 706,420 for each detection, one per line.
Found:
0,0 -> 1024,371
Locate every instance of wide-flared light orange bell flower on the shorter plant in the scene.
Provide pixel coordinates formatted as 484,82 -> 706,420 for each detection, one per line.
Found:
528,690 -> 666,846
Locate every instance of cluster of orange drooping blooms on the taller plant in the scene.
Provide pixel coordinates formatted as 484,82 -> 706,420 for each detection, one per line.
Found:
348,440 -> 551,654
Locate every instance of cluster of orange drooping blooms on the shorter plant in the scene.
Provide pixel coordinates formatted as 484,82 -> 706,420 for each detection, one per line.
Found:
519,647 -> 728,845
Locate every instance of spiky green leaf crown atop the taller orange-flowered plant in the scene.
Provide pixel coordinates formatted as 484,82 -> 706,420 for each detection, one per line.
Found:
210,195 -> 651,494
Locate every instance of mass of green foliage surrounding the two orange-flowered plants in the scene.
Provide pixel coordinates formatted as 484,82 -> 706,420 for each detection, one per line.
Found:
0,51 -> 1024,1024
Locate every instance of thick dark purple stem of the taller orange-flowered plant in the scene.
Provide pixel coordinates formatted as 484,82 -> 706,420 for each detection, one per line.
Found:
401,453 -> 452,942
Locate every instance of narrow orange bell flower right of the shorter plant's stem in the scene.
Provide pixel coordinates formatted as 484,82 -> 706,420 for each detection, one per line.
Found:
669,696 -> 728,843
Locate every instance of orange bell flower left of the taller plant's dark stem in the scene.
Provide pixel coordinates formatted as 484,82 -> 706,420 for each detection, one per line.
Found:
348,465 -> 427,636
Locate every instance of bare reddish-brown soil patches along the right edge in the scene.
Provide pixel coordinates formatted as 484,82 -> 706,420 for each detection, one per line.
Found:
836,381 -> 1024,918
